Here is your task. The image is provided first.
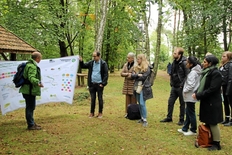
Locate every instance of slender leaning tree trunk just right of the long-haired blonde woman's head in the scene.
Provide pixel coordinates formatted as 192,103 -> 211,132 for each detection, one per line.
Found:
154,0 -> 163,77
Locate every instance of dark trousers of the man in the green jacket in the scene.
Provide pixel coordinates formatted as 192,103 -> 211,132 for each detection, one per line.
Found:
23,94 -> 36,127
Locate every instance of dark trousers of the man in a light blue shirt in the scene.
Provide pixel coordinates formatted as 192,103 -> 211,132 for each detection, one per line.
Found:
89,83 -> 104,114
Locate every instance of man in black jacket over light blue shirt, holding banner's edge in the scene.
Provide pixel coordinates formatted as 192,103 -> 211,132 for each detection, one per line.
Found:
79,51 -> 108,118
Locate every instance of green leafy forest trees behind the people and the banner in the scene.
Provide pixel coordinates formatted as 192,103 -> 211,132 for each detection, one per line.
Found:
0,0 -> 232,77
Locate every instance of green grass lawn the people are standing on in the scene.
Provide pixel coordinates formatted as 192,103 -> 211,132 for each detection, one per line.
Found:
0,71 -> 232,155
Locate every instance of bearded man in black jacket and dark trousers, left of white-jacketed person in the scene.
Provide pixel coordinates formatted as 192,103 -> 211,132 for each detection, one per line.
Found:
160,47 -> 189,125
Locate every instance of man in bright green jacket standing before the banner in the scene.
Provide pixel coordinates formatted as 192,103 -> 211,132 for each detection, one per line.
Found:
19,52 -> 43,130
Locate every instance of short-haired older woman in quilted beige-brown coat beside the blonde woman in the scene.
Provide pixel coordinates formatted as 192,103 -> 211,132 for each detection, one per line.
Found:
121,52 -> 137,117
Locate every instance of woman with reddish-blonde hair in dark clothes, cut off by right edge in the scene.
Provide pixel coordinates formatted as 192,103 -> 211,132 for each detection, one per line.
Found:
219,51 -> 232,126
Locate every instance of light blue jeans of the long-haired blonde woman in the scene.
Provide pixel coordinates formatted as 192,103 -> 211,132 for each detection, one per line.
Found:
136,91 -> 147,119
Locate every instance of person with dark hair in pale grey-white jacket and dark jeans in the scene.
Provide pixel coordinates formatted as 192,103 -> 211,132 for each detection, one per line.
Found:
177,56 -> 201,136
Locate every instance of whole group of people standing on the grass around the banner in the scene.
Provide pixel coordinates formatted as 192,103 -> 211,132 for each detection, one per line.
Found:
20,47 -> 232,150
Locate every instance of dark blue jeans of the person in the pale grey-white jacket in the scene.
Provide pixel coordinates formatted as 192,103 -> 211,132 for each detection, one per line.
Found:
182,102 -> 197,133
